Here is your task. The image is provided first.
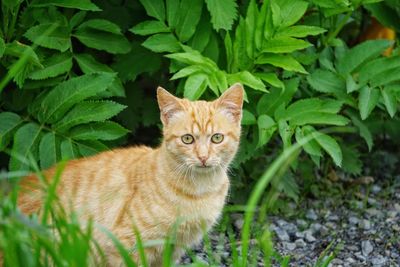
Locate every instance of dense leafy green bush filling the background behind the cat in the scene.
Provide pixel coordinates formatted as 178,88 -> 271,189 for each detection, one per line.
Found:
0,0 -> 400,201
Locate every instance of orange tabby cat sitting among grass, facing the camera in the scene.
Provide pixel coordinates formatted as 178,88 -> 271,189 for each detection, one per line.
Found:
19,84 -> 243,266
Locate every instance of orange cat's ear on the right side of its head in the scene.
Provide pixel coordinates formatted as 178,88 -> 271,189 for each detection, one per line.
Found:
217,83 -> 244,122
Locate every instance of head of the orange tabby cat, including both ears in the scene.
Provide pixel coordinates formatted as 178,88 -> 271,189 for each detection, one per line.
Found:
157,84 -> 244,175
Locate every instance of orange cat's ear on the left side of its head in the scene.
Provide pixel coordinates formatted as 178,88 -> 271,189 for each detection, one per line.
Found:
157,87 -> 183,125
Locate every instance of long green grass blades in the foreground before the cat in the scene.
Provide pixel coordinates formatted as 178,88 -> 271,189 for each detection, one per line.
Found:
0,137 -> 335,267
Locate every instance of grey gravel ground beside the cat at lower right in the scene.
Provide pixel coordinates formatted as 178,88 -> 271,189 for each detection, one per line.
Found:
181,151 -> 400,266
